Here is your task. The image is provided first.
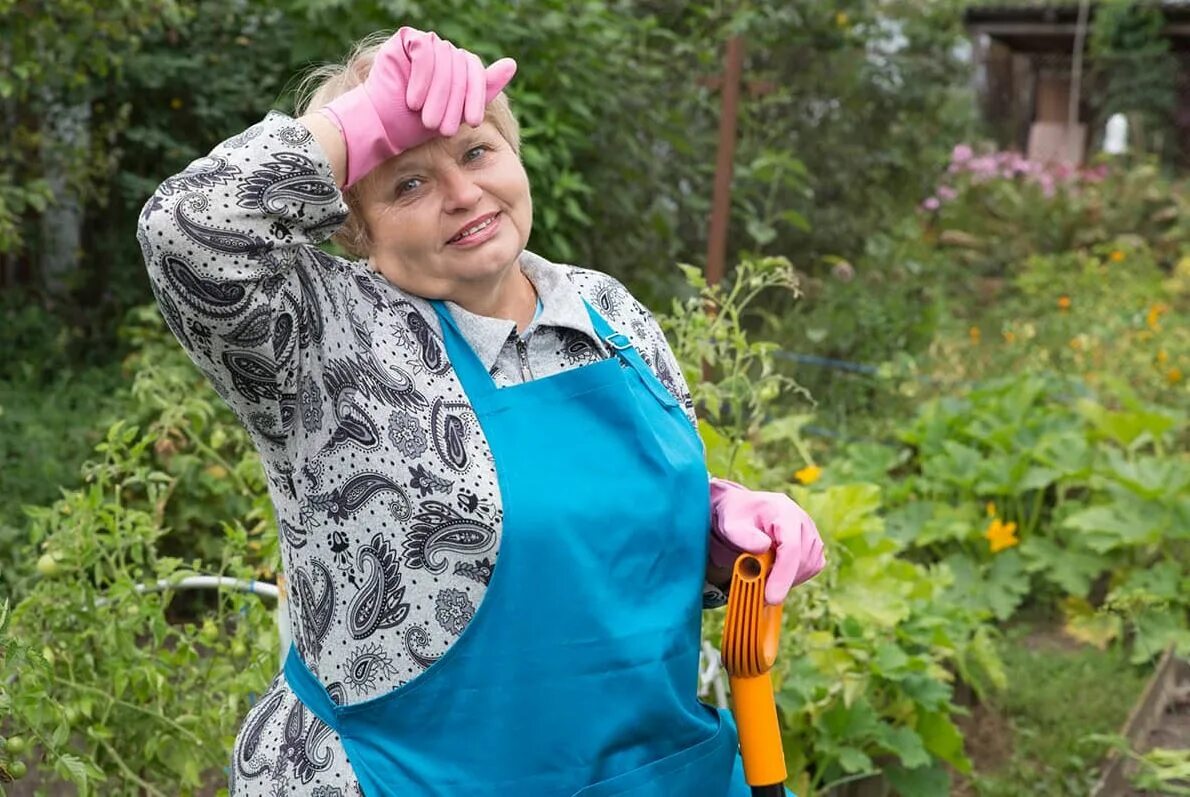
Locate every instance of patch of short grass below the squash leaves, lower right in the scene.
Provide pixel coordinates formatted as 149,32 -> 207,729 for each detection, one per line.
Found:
962,623 -> 1148,797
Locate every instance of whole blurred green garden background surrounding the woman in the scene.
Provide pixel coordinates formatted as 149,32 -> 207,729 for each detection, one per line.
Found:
0,0 -> 1190,797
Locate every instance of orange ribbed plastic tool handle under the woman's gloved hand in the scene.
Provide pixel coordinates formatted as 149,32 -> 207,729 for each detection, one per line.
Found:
724,551 -> 788,797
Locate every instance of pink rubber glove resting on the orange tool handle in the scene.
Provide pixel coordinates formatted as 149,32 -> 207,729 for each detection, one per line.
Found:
710,478 -> 826,604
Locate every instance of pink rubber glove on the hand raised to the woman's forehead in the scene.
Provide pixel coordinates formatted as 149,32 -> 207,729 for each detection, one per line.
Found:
319,27 -> 516,188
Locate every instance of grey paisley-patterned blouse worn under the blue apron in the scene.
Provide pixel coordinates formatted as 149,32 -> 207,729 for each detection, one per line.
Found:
137,112 -> 722,797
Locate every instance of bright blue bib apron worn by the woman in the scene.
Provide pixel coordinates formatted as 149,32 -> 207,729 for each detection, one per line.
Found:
284,302 -> 750,797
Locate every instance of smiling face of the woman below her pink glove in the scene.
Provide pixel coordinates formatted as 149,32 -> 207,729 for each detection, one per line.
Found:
361,121 -> 533,301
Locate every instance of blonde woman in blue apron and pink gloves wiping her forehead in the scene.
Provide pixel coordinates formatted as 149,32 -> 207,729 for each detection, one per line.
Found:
138,29 -> 822,797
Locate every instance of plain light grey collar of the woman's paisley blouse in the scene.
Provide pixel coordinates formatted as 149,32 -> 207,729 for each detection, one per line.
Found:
445,250 -> 603,371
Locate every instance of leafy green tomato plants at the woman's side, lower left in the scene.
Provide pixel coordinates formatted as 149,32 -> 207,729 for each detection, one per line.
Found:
0,309 -> 277,795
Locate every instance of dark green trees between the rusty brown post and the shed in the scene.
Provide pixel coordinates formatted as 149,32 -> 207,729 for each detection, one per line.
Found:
728,0 -> 975,272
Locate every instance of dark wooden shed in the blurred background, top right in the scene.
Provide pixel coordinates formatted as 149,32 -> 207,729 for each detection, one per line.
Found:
964,0 -> 1190,163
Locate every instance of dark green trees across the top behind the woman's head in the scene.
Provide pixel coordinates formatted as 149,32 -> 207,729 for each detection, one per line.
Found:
11,0 -> 970,316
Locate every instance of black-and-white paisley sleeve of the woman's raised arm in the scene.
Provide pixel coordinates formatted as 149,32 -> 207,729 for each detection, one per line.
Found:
137,112 -> 347,456
